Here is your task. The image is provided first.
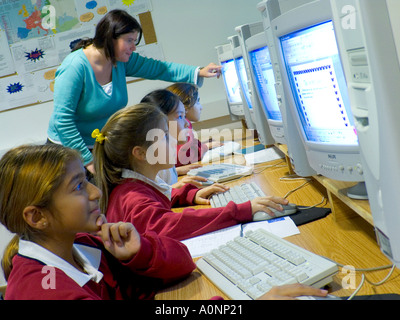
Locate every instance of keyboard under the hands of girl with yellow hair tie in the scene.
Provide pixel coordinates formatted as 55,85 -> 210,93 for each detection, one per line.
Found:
210,182 -> 298,221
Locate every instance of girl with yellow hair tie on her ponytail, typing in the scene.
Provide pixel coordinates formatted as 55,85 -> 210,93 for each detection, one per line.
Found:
94,104 -> 288,240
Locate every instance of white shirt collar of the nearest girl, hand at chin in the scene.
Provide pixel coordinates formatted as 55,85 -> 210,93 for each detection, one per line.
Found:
18,239 -> 103,287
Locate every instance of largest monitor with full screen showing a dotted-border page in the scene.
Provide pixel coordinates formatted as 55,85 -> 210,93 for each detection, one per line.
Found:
272,0 -> 368,199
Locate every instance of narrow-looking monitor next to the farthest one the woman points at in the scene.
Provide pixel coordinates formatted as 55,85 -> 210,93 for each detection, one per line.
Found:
228,35 -> 256,130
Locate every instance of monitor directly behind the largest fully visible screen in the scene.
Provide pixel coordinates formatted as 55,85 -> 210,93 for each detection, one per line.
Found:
246,32 -> 286,144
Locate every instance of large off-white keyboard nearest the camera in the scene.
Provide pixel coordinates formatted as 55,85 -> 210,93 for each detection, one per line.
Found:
196,229 -> 338,300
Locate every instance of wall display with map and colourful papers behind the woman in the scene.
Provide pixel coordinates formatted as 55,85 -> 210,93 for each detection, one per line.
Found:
0,0 -> 164,112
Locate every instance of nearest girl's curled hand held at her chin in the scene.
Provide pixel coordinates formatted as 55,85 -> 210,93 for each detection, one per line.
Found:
97,222 -> 141,260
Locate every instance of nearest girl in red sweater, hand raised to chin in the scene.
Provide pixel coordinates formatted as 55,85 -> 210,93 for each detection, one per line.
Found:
0,145 -> 195,300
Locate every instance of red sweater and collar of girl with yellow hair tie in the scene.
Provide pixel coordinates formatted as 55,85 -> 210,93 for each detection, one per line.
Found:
106,170 -> 252,240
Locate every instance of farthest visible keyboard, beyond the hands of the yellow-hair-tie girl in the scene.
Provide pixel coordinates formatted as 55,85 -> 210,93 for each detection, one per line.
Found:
187,163 -> 253,182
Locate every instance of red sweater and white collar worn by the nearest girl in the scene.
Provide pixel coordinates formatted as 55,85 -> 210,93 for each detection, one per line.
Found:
5,232 -> 195,300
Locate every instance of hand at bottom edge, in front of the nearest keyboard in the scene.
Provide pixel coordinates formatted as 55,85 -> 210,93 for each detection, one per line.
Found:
258,283 -> 328,300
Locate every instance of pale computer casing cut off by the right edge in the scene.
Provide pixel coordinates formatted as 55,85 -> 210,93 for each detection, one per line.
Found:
331,0 -> 400,267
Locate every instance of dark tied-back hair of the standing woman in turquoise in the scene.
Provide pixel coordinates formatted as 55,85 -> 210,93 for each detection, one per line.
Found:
72,9 -> 142,64
